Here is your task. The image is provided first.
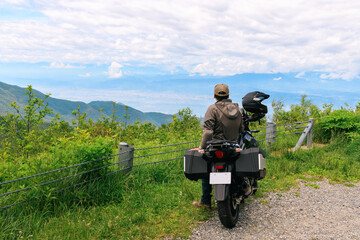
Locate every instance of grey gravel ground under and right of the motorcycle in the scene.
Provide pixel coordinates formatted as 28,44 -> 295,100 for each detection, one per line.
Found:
190,180 -> 360,240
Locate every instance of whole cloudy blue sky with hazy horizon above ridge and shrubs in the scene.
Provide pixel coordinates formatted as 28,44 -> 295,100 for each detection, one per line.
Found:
0,0 -> 360,116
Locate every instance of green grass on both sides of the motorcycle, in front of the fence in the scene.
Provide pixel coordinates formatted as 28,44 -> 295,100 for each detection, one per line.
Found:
0,137 -> 360,239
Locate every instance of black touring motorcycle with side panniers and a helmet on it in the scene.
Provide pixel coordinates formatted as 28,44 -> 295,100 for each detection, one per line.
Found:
184,92 -> 269,228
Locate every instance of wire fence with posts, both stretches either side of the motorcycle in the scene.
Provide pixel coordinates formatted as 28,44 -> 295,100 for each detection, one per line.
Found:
0,119 -> 314,210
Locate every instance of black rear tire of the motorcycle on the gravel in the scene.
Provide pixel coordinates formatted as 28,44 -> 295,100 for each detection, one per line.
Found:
217,193 -> 240,228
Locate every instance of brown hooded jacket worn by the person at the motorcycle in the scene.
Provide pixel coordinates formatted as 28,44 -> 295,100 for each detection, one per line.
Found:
201,99 -> 244,148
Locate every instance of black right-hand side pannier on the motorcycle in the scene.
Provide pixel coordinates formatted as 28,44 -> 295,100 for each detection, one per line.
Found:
235,148 -> 266,179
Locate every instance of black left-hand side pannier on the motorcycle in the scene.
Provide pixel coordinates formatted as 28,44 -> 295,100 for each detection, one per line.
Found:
184,150 -> 209,180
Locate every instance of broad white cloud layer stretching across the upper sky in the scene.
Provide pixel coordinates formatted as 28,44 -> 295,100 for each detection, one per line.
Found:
0,0 -> 360,80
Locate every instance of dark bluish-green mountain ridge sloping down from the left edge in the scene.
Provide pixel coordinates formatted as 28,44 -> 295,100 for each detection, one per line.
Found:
0,82 -> 172,126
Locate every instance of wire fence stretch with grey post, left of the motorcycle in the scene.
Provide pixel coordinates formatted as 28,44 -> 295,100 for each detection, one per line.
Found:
0,141 -> 200,210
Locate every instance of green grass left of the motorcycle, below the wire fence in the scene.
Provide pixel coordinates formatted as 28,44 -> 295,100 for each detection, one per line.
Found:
0,161 -> 211,239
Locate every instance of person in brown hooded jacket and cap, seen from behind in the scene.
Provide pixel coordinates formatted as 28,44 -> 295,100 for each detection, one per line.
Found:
193,84 -> 244,209
